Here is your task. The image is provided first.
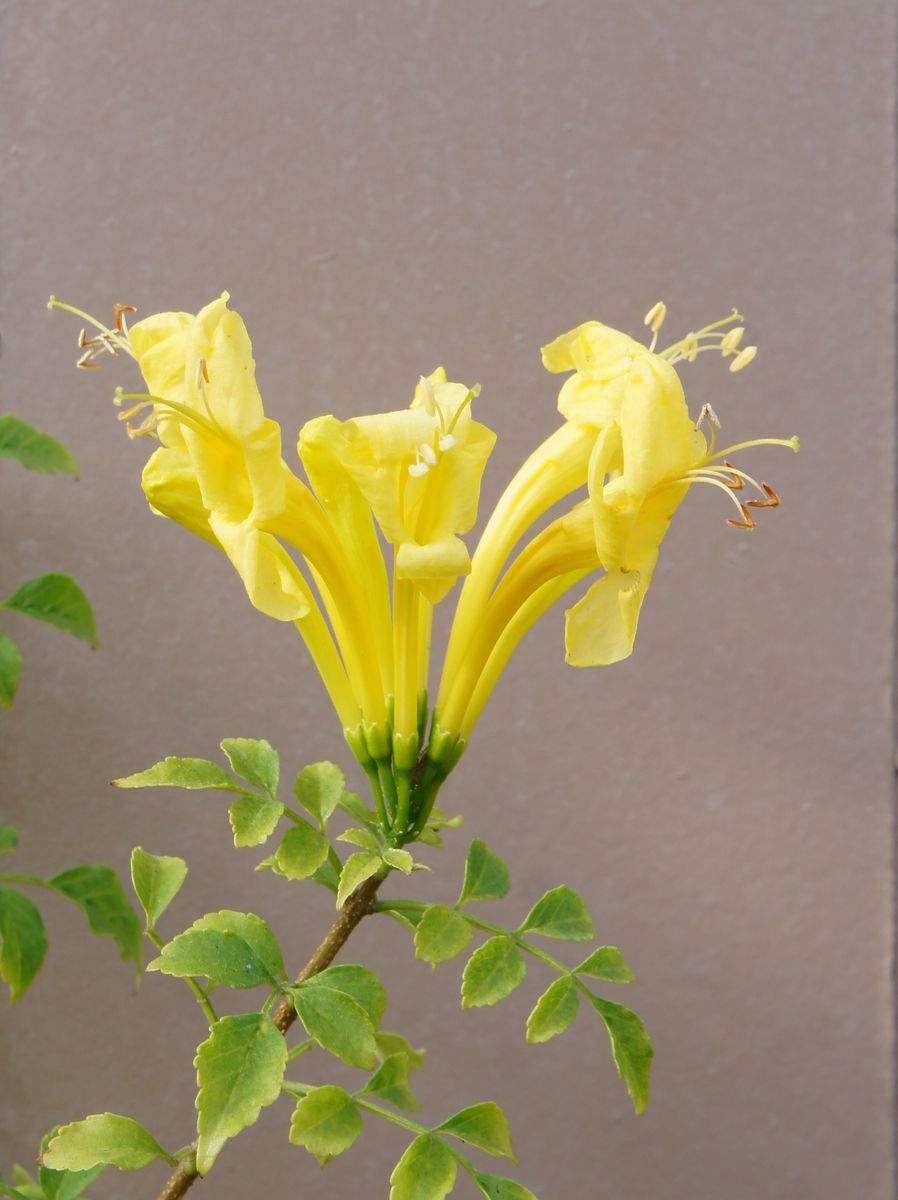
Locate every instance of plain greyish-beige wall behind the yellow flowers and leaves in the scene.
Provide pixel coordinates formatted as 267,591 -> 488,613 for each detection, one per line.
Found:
0,0 -> 896,1200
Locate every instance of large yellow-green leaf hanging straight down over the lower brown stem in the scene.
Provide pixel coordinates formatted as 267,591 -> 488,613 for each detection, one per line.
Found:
194,1013 -> 287,1175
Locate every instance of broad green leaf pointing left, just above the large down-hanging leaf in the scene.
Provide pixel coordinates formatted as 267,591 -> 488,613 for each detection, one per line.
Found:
146,908 -> 287,988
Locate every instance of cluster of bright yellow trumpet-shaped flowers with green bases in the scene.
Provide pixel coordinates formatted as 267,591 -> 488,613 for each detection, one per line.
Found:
50,294 -> 798,845
